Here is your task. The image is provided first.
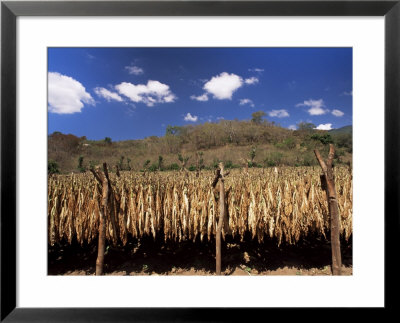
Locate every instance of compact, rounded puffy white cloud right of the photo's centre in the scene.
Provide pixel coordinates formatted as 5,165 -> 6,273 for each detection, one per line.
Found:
203,72 -> 243,100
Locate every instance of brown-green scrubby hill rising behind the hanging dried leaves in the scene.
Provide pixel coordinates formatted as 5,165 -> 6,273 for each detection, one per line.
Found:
48,120 -> 352,173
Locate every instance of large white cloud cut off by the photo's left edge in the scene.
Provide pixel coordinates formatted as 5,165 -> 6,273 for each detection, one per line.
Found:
48,72 -> 95,114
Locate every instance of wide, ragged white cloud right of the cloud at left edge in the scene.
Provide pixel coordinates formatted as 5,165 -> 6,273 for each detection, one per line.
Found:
115,80 -> 176,107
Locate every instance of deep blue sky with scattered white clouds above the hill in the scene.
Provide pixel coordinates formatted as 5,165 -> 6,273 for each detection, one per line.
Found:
48,48 -> 353,141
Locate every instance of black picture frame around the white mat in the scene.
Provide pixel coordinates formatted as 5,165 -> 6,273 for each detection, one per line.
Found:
0,0 -> 400,322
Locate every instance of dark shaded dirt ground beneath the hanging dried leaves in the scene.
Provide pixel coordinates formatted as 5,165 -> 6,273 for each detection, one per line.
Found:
48,237 -> 353,276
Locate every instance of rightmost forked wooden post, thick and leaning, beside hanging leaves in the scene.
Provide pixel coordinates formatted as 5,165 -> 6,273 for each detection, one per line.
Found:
314,144 -> 342,275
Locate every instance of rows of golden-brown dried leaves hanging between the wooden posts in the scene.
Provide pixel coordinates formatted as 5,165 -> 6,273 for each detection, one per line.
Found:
48,165 -> 352,245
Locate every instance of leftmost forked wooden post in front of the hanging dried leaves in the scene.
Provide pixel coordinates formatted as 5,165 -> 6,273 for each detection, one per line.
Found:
91,163 -> 109,276
